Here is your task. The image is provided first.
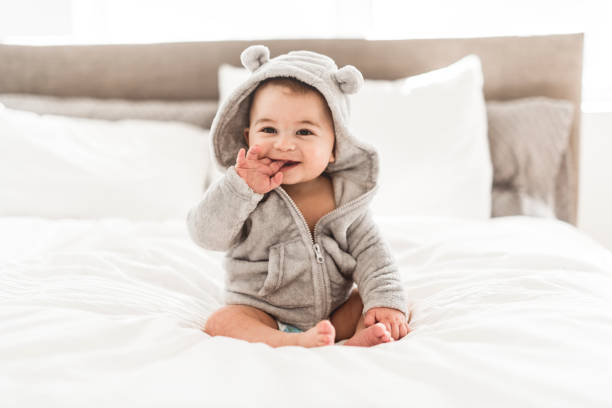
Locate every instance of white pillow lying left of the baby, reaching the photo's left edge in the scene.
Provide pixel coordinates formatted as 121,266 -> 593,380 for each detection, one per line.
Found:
0,107 -> 212,220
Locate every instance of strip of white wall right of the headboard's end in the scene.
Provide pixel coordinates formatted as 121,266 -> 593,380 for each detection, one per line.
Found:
578,111 -> 612,250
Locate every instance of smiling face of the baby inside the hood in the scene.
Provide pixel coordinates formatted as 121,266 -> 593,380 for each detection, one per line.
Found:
244,84 -> 335,184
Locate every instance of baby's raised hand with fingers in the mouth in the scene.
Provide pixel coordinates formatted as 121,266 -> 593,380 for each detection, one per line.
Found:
234,145 -> 285,194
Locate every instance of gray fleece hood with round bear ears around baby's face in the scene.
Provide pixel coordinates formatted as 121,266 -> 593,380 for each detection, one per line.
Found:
210,45 -> 379,205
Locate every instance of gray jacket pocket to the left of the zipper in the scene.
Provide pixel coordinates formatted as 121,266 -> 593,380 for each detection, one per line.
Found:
258,238 -> 313,307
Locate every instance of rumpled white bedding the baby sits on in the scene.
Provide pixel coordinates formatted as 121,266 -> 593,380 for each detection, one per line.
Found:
0,217 -> 612,408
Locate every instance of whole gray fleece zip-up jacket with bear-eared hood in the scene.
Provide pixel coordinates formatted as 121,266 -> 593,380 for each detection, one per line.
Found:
187,45 -> 408,330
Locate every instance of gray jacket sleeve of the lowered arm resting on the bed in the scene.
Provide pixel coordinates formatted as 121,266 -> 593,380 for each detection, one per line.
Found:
347,210 -> 409,315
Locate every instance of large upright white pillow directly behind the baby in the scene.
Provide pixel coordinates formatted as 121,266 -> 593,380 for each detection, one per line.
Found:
218,55 -> 493,219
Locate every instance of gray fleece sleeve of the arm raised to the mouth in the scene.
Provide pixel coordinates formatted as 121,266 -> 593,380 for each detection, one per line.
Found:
186,166 -> 264,251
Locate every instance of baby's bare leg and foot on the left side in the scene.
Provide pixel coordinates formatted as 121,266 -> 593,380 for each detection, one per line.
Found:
204,305 -> 335,347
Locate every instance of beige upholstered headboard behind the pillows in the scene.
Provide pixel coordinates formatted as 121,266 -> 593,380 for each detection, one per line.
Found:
0,33 -> 584,225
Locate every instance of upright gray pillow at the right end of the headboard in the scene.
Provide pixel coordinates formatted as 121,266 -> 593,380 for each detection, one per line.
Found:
486,97 -> 574,221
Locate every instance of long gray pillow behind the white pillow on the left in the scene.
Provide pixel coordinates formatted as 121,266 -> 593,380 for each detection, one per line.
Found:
0,94 -> 218,129
